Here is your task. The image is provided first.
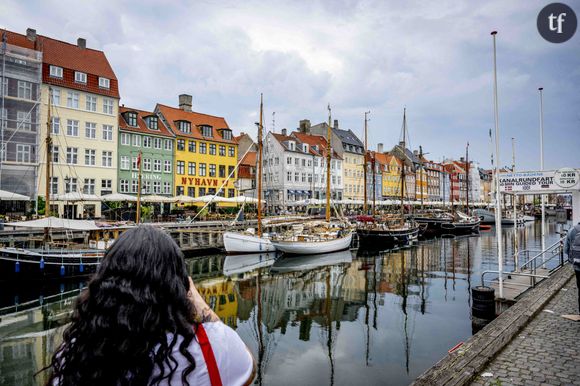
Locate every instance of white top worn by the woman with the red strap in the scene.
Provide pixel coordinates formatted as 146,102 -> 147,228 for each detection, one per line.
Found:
152,322 -> 254,386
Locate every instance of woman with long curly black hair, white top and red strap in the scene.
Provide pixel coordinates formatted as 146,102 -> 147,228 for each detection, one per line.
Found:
47,226 -> 254,386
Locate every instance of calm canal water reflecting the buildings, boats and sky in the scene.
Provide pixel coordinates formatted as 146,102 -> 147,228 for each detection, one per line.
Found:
0,222 -> 572,385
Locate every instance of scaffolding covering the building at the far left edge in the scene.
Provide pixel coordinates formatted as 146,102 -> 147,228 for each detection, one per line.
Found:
0,35 -> 42,199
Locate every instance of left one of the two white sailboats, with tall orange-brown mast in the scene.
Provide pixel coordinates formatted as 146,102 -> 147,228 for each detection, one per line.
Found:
223,95 -> 276,253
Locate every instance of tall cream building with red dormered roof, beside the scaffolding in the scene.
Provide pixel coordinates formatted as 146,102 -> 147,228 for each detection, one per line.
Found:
35,36 -> 119,218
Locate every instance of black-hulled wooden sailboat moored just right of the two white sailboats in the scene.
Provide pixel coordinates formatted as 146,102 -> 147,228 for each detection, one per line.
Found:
356,107 -> 420,249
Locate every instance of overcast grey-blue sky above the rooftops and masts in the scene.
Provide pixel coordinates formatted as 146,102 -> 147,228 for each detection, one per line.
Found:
0,0 -> 580,170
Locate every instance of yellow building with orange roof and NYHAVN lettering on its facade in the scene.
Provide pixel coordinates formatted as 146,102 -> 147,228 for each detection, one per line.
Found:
155,95 -> 238,206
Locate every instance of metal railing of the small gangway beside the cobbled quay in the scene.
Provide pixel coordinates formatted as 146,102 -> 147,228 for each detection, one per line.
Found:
481,234 -> 566,288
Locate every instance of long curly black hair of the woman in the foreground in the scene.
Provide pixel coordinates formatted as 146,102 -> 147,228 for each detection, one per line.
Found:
45,226 -> 195,386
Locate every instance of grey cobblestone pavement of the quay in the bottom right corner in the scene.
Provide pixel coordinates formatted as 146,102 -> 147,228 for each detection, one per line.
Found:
472,277 -> 580,386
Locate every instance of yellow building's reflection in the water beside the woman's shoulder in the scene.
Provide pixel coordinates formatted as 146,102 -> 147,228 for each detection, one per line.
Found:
196,277 -> 238,328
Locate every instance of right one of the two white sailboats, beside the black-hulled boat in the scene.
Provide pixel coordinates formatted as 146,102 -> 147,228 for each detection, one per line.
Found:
272,105 -> 352,255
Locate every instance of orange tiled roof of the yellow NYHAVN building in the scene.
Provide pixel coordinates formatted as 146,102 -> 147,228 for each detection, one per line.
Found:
155,103 -> 237,144
